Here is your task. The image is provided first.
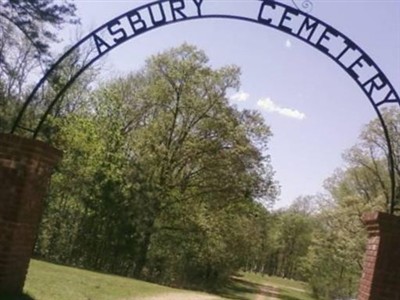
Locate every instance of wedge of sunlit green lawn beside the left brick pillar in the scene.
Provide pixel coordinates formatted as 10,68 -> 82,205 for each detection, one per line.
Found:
24,260 -> 217,300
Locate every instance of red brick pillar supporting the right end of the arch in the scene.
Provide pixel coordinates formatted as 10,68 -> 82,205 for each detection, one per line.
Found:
358,212 -> 400,300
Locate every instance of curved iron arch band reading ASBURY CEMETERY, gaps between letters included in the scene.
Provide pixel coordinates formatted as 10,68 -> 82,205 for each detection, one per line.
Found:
11,0 -> 400,213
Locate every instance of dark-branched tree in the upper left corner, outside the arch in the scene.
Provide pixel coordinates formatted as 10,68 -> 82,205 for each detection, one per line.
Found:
0,0 -> 78,131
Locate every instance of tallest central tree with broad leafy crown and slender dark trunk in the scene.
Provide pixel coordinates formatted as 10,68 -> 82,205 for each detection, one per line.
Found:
117,45 -> 272,282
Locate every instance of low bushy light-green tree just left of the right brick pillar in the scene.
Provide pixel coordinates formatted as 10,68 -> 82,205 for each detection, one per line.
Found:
305,192 -> 366,299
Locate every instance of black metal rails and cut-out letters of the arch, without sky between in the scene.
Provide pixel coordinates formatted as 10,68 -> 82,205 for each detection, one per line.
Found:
11,0 -> 400,213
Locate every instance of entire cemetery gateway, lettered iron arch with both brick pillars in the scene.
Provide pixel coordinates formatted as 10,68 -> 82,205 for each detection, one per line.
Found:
0,0 -> 400,300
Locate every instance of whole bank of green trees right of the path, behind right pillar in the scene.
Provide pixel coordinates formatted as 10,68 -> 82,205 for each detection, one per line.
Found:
252,108 -> 400,299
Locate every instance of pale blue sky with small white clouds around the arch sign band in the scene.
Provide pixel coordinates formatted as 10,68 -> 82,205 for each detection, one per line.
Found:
66,0 -> 400,207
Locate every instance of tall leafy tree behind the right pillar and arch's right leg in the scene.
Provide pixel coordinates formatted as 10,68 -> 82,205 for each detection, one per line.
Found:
308,107 -> 400,299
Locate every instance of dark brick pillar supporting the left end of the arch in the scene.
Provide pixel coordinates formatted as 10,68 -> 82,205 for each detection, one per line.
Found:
0,134 -> 61,298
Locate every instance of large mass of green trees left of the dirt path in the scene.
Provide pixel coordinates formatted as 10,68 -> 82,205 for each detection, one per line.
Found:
36,44 -> 277,287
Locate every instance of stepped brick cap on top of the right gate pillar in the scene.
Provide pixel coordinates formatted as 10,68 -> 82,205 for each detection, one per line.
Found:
362,212 -> 400,236
